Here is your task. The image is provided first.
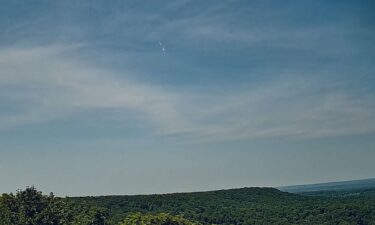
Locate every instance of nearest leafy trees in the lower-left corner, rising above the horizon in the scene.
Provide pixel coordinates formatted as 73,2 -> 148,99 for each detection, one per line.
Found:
0,187 -> 106,225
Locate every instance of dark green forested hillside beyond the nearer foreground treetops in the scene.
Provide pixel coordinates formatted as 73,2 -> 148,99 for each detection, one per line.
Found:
72,188 -> 375,225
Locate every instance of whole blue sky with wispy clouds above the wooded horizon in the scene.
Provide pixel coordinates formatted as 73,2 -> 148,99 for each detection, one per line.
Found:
0,0 -> 375,196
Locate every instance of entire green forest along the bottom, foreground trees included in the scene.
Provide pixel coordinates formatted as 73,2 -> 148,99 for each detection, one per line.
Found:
0,187 -> 375,225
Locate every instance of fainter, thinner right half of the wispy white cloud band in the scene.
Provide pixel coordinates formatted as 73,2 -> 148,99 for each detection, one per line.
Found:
191,80 -> 375,140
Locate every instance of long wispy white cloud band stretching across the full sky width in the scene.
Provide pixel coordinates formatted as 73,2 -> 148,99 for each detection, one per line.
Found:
0,45 -> 375,142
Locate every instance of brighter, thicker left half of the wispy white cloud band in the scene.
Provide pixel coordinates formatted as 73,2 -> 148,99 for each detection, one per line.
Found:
0,46 -> 191,132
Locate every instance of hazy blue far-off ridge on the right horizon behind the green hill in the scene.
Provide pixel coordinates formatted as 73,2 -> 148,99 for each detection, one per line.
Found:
277,178 -> 375,193
